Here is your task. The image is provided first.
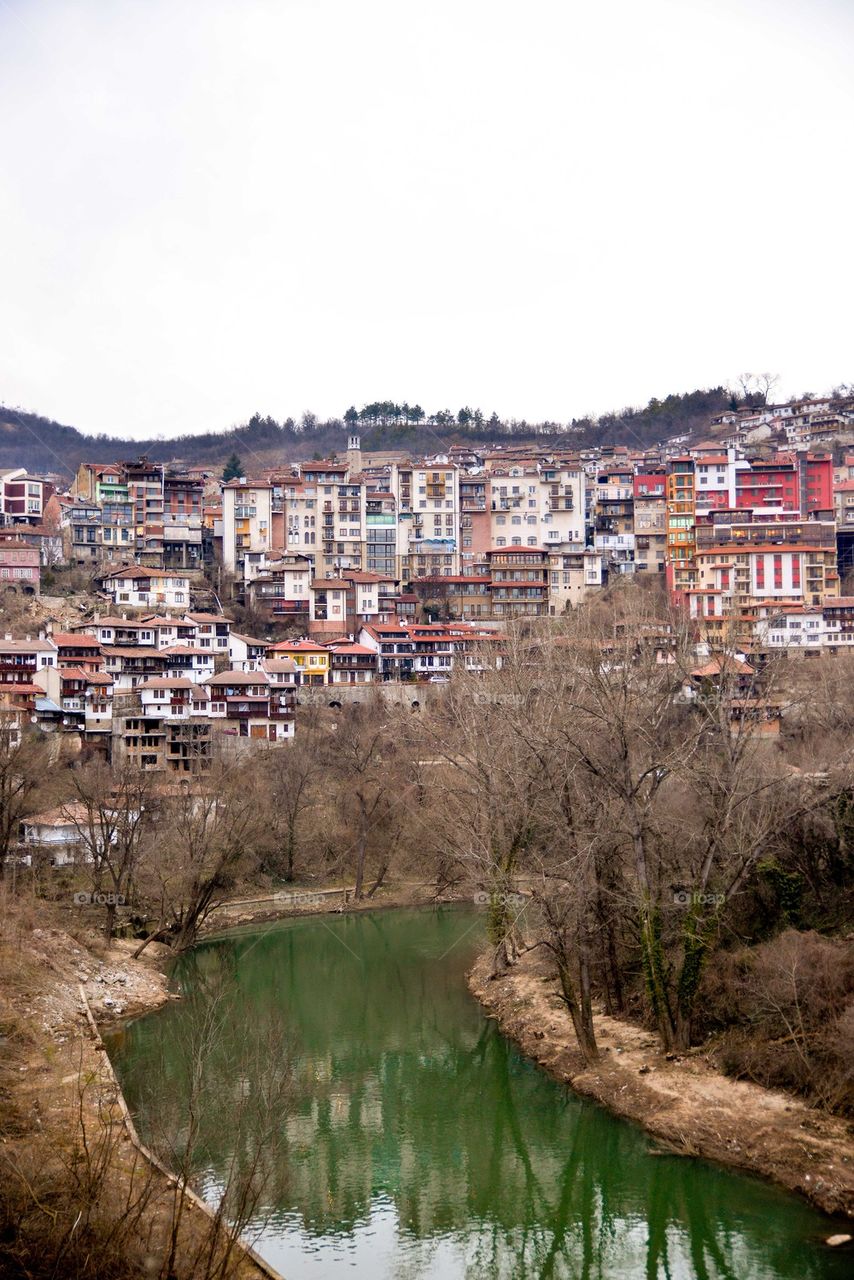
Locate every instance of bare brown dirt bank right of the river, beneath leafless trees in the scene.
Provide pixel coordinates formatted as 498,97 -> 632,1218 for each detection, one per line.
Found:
469,950 -> 854,1219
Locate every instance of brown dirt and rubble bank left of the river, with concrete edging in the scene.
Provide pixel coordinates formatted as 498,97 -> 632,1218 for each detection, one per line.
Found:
0,920 -> 277,1280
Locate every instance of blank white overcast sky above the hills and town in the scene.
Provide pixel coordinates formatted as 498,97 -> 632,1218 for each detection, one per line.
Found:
0,0 -> 854,435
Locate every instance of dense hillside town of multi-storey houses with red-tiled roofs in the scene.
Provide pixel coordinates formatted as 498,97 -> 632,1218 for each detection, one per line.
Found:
0,391 -> 854,774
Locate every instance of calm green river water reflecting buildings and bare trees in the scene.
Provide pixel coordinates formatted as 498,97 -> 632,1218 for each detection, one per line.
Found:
109,909 -> 850,1280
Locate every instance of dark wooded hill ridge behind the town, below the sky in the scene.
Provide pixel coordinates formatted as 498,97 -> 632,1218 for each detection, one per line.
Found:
0,387 -> 737,477
